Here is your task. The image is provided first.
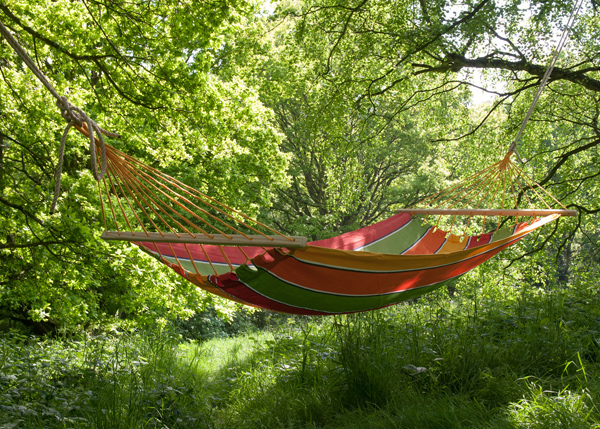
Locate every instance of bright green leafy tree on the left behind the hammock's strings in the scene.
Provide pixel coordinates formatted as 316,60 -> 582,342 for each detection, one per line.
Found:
0,0 -> 286,329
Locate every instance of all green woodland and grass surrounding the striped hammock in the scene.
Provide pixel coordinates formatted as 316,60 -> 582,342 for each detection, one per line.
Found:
0,0 -> 600,427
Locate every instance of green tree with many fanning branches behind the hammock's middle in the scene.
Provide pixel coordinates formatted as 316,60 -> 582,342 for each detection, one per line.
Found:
218,5 -> 476,239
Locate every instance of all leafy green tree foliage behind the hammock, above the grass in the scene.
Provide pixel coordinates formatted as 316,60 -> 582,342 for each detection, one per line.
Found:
0,0 -> 600,335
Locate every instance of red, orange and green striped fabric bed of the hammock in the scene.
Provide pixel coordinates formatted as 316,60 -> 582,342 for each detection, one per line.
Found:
138,213 -> 558,315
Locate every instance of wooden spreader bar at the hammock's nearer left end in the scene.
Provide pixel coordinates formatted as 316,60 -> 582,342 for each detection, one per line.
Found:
100,231 -> 308,249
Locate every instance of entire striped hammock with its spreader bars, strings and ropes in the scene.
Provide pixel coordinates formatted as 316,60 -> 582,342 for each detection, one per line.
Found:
0,15 -> 576,315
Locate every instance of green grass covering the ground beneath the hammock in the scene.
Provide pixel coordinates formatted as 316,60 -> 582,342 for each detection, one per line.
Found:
0,274 -> 600,428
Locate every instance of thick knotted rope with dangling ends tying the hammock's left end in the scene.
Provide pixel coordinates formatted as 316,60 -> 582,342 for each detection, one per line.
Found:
0,17 -> 120,214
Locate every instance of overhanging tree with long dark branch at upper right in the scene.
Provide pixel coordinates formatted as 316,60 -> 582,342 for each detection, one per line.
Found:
278,0 -> 600,191
